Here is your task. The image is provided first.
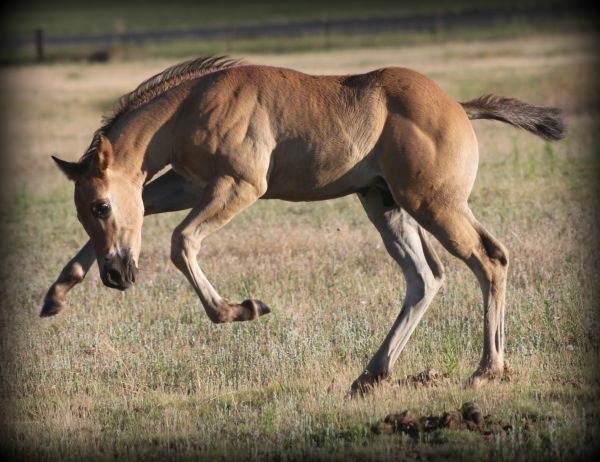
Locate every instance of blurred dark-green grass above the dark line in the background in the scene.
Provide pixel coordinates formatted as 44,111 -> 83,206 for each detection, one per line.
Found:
4,0 -> 568,36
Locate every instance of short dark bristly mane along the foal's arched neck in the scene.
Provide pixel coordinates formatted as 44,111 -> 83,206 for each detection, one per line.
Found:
82,56 -> 243,159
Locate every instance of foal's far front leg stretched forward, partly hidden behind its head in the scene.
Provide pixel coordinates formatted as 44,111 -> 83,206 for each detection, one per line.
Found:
40,170 -> 202,317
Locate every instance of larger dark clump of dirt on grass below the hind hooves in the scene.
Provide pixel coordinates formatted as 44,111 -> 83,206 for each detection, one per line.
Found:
373,401 -> 512,438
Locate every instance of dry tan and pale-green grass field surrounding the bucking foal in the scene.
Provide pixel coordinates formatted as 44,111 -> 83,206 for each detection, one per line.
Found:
0,34 -> 600,460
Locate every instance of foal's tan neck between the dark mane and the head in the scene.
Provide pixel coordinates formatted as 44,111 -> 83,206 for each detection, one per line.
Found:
109,88 -> 185,184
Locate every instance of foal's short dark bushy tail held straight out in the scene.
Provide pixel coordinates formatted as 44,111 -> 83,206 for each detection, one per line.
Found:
460,95 -> 566,141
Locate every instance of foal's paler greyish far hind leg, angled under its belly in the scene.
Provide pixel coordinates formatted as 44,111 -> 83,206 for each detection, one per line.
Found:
350,188 -> 444,395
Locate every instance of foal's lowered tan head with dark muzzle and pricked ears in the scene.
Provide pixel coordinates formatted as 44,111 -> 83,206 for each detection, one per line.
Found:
53,135 -> 144,290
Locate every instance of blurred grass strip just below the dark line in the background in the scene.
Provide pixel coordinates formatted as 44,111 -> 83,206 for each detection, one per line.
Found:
0,18 -> 589,64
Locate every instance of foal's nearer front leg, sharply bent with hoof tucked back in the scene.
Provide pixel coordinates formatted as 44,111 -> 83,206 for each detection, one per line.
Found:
171,176 -> 271,323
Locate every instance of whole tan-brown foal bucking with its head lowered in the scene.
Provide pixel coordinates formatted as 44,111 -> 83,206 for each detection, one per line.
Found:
41,54 -> 564,392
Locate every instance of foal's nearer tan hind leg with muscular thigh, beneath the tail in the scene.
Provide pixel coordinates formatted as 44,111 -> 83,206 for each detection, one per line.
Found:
379,106 -> 508,386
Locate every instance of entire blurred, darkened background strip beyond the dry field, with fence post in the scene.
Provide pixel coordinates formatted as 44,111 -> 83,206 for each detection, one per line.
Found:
0,0 -> 595,63
